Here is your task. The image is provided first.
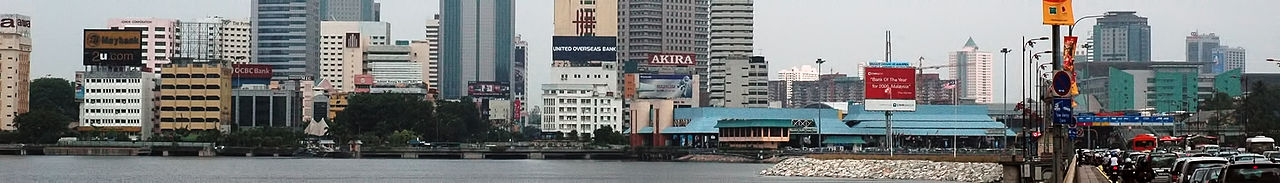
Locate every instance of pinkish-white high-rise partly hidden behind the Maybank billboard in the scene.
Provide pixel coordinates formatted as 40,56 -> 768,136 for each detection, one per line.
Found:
108,18 -> 182,74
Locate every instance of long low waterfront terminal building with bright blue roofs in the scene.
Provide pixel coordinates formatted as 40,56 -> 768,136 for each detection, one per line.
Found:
628,101 -> 1015,148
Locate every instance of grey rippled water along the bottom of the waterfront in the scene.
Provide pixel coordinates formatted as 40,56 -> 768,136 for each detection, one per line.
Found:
0,156 -> 952,183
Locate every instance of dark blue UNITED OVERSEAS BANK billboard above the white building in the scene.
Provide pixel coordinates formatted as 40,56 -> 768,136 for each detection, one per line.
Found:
552,36 -> 618,61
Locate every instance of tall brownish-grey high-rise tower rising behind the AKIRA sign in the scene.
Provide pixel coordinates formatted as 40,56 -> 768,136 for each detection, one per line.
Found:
618,0 -> 710,97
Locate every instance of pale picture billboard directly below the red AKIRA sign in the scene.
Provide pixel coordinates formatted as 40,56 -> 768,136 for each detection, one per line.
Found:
635,74 -> 698,99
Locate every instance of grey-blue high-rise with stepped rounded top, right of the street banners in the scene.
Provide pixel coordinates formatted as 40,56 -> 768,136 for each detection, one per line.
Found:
1092,12 -> 1151,61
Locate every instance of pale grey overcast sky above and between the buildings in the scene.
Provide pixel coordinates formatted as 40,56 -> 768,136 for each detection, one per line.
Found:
0,0 -> 1280,105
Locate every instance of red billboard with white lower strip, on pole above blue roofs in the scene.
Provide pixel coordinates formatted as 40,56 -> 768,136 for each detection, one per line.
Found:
863,68 -> 915,111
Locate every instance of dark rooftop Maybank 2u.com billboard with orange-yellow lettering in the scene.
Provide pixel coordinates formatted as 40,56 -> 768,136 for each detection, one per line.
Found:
83,29 -> 143,67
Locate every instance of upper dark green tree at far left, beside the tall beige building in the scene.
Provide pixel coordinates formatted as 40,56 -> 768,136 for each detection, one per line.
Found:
28,78 -> 79,120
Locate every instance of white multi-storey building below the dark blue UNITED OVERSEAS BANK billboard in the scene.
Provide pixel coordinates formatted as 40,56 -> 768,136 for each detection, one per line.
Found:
541,63 -> 623,134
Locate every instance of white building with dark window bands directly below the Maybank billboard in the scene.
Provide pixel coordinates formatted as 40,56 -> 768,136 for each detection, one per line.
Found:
79,70 -> 156,139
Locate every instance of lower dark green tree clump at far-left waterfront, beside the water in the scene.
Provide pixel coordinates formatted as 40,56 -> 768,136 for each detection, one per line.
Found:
14,110 -> 72,143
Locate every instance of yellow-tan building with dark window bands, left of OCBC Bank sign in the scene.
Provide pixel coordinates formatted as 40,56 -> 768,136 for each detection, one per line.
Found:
160,63 -> 232,132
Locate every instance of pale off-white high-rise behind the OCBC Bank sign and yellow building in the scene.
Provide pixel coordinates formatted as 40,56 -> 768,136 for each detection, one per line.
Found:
178,17 -> 252,64
